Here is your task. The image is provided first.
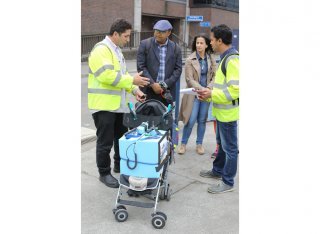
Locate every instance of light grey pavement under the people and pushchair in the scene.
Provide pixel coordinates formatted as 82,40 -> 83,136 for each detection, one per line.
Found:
81,60 -> 239,234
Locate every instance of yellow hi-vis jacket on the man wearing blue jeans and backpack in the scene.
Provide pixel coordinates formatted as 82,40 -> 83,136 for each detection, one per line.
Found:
210,55 -> 239,122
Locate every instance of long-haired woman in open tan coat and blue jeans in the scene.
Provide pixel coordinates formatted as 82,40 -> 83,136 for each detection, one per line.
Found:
178,35 -> 216,154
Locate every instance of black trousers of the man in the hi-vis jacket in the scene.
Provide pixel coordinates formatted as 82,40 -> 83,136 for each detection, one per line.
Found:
92,111 -> 128,176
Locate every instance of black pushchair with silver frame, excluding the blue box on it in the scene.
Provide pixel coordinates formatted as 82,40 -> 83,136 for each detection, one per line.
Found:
112,99 -> 174,229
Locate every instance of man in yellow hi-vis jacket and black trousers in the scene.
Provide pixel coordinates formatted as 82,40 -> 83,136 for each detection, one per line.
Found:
88,19 -> 149,188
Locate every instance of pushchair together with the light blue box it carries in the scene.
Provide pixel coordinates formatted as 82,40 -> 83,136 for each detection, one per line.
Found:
112,99 -> 174,229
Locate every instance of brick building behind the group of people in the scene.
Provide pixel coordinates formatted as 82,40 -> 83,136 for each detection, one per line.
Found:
81,0 -> 239,57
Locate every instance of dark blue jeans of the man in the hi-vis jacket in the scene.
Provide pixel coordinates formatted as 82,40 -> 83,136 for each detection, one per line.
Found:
212,120 -> 238,186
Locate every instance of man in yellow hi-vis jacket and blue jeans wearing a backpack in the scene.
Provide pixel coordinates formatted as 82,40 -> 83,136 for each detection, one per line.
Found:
197,24 -> 239,193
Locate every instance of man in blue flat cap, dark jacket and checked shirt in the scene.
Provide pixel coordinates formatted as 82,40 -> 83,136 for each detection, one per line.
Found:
137,20 -> 182,106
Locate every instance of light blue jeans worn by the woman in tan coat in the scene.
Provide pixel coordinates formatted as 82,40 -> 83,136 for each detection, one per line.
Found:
181,99 -> 210,145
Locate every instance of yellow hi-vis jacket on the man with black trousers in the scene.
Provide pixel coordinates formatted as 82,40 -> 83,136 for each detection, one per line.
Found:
88,41 -> 137,111
